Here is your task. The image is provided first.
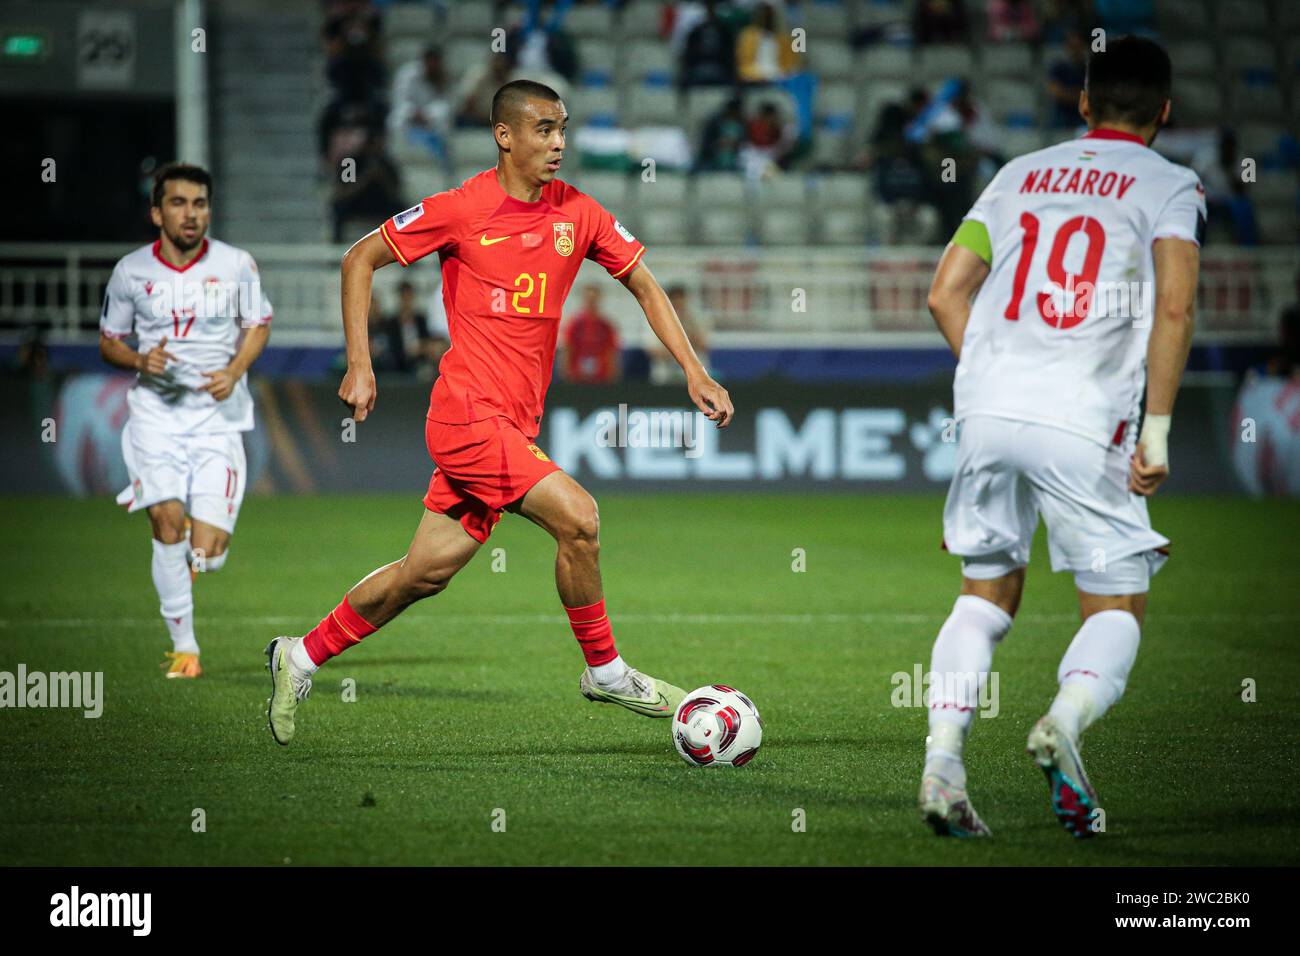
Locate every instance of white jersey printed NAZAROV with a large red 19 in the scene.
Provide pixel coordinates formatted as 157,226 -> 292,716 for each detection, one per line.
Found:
953,130 -> 1205,445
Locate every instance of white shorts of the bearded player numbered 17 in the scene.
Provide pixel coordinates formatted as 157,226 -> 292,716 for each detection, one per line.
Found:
117,419 -> 248,533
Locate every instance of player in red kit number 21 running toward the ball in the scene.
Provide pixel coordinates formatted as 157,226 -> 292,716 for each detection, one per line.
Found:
267,81 -> 733,744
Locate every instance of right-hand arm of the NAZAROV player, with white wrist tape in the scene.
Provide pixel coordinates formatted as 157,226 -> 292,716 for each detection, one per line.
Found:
1128,238 -> 1201,494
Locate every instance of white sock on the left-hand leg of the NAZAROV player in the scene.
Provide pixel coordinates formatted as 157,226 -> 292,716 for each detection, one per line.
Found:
926,594 -> 1011,787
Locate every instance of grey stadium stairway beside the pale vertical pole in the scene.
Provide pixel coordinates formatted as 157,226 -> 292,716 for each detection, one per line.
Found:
208,0 -> 329,245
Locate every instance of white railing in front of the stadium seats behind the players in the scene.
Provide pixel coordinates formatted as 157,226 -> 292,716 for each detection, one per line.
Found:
0,243 -> 1300,346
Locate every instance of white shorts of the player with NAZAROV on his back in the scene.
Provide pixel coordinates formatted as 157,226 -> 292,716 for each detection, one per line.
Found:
944,415 -> 1169,594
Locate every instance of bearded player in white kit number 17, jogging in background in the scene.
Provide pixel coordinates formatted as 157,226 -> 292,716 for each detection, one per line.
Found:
99,164 -> 270,678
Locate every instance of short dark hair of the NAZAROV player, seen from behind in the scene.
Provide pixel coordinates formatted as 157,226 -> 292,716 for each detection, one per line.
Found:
1083,36 -> 1173,126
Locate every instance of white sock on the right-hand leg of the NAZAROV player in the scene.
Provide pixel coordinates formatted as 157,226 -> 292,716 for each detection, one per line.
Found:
1048,609 -> 1141,740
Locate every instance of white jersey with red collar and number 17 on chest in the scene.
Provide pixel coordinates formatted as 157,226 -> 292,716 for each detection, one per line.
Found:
99,239 -> 272,434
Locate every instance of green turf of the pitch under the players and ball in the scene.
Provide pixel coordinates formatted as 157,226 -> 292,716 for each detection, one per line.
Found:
0,494 -> 1300,865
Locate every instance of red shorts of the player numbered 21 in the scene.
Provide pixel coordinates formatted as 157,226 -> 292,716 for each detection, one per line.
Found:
424,416 -> 560,544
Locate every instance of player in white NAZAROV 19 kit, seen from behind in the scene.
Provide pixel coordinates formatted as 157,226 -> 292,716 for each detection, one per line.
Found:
919,36 -> 1205,838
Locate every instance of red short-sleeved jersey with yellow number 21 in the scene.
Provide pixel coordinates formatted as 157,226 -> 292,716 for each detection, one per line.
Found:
380,169 -> 645,438
